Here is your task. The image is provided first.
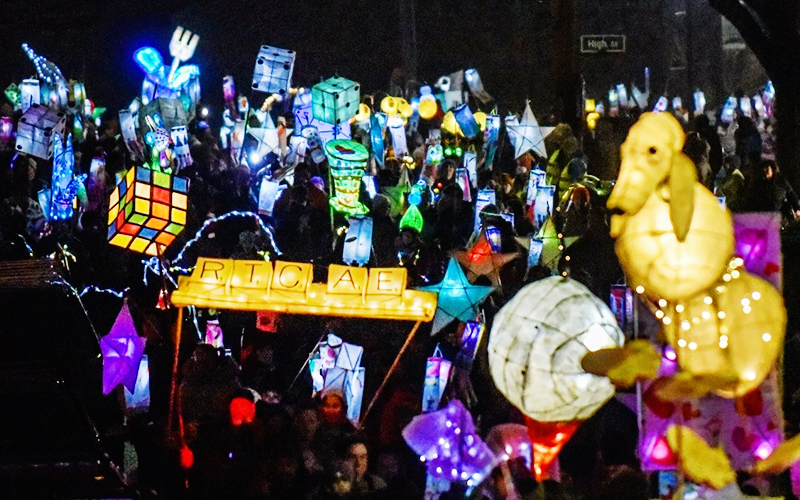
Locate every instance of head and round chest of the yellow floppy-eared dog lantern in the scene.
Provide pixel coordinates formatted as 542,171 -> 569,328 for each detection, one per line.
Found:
608,113 -> 734,300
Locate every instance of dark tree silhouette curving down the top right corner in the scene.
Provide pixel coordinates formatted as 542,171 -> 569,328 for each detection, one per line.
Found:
708,0 -> 800,188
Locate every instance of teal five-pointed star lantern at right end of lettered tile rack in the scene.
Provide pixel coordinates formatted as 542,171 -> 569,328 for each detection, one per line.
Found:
419,257 -> 494,334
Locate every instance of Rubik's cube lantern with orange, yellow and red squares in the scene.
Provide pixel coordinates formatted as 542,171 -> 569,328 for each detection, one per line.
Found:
108,167 -> 189,255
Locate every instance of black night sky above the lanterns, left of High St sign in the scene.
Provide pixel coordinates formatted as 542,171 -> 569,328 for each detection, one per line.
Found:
0,0 -> 551,119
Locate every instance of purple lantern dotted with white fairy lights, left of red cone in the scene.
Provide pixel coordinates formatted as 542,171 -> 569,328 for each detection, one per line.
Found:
403,400 -> 497,488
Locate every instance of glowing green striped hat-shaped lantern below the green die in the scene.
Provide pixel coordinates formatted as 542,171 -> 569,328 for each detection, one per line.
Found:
325,139 -> 369,215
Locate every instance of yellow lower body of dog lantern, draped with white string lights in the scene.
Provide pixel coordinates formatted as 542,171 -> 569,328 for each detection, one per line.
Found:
656,264 -> 786,397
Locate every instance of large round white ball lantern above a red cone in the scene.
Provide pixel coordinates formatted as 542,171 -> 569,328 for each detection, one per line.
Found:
488,277 -> 625,422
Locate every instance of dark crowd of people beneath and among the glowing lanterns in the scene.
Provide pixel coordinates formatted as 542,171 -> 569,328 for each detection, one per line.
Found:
0,75 -> 800,500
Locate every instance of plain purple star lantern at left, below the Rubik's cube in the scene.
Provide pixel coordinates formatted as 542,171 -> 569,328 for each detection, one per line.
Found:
100,302 -> 147,394
